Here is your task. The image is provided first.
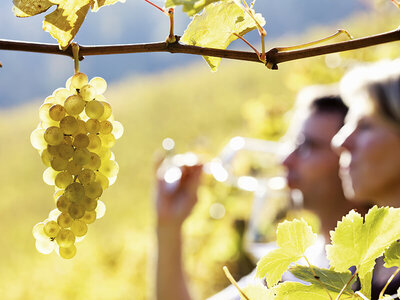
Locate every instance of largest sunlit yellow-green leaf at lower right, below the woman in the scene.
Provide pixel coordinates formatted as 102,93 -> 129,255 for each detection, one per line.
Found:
326,206 -> 400,297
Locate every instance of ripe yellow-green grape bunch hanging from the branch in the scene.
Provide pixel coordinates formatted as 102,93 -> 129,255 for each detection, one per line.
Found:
31,72 -> 123,259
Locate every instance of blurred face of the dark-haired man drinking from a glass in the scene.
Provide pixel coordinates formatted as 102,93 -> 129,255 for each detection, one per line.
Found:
283,112 -> 343,210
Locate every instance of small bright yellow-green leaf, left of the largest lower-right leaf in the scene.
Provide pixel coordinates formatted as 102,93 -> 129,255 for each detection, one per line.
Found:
256,220 -> 317,287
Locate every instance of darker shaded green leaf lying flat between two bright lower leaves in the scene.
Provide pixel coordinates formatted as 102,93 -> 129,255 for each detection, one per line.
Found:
289,266 -> 356,295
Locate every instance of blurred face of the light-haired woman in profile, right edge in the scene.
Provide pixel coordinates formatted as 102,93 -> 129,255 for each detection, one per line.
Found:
332,108 -> 400,204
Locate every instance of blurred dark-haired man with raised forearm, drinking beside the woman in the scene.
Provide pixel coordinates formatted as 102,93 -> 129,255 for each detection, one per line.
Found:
157,86 -> 366,300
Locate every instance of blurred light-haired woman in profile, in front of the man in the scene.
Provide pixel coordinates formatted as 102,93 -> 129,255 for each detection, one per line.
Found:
332,60 -> 400,299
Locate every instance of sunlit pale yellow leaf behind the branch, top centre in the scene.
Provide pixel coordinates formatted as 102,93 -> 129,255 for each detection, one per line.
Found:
181,1 -> 265,71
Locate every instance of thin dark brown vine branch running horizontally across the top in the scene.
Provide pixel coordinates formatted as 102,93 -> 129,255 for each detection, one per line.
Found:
0,28 -> 400,69
